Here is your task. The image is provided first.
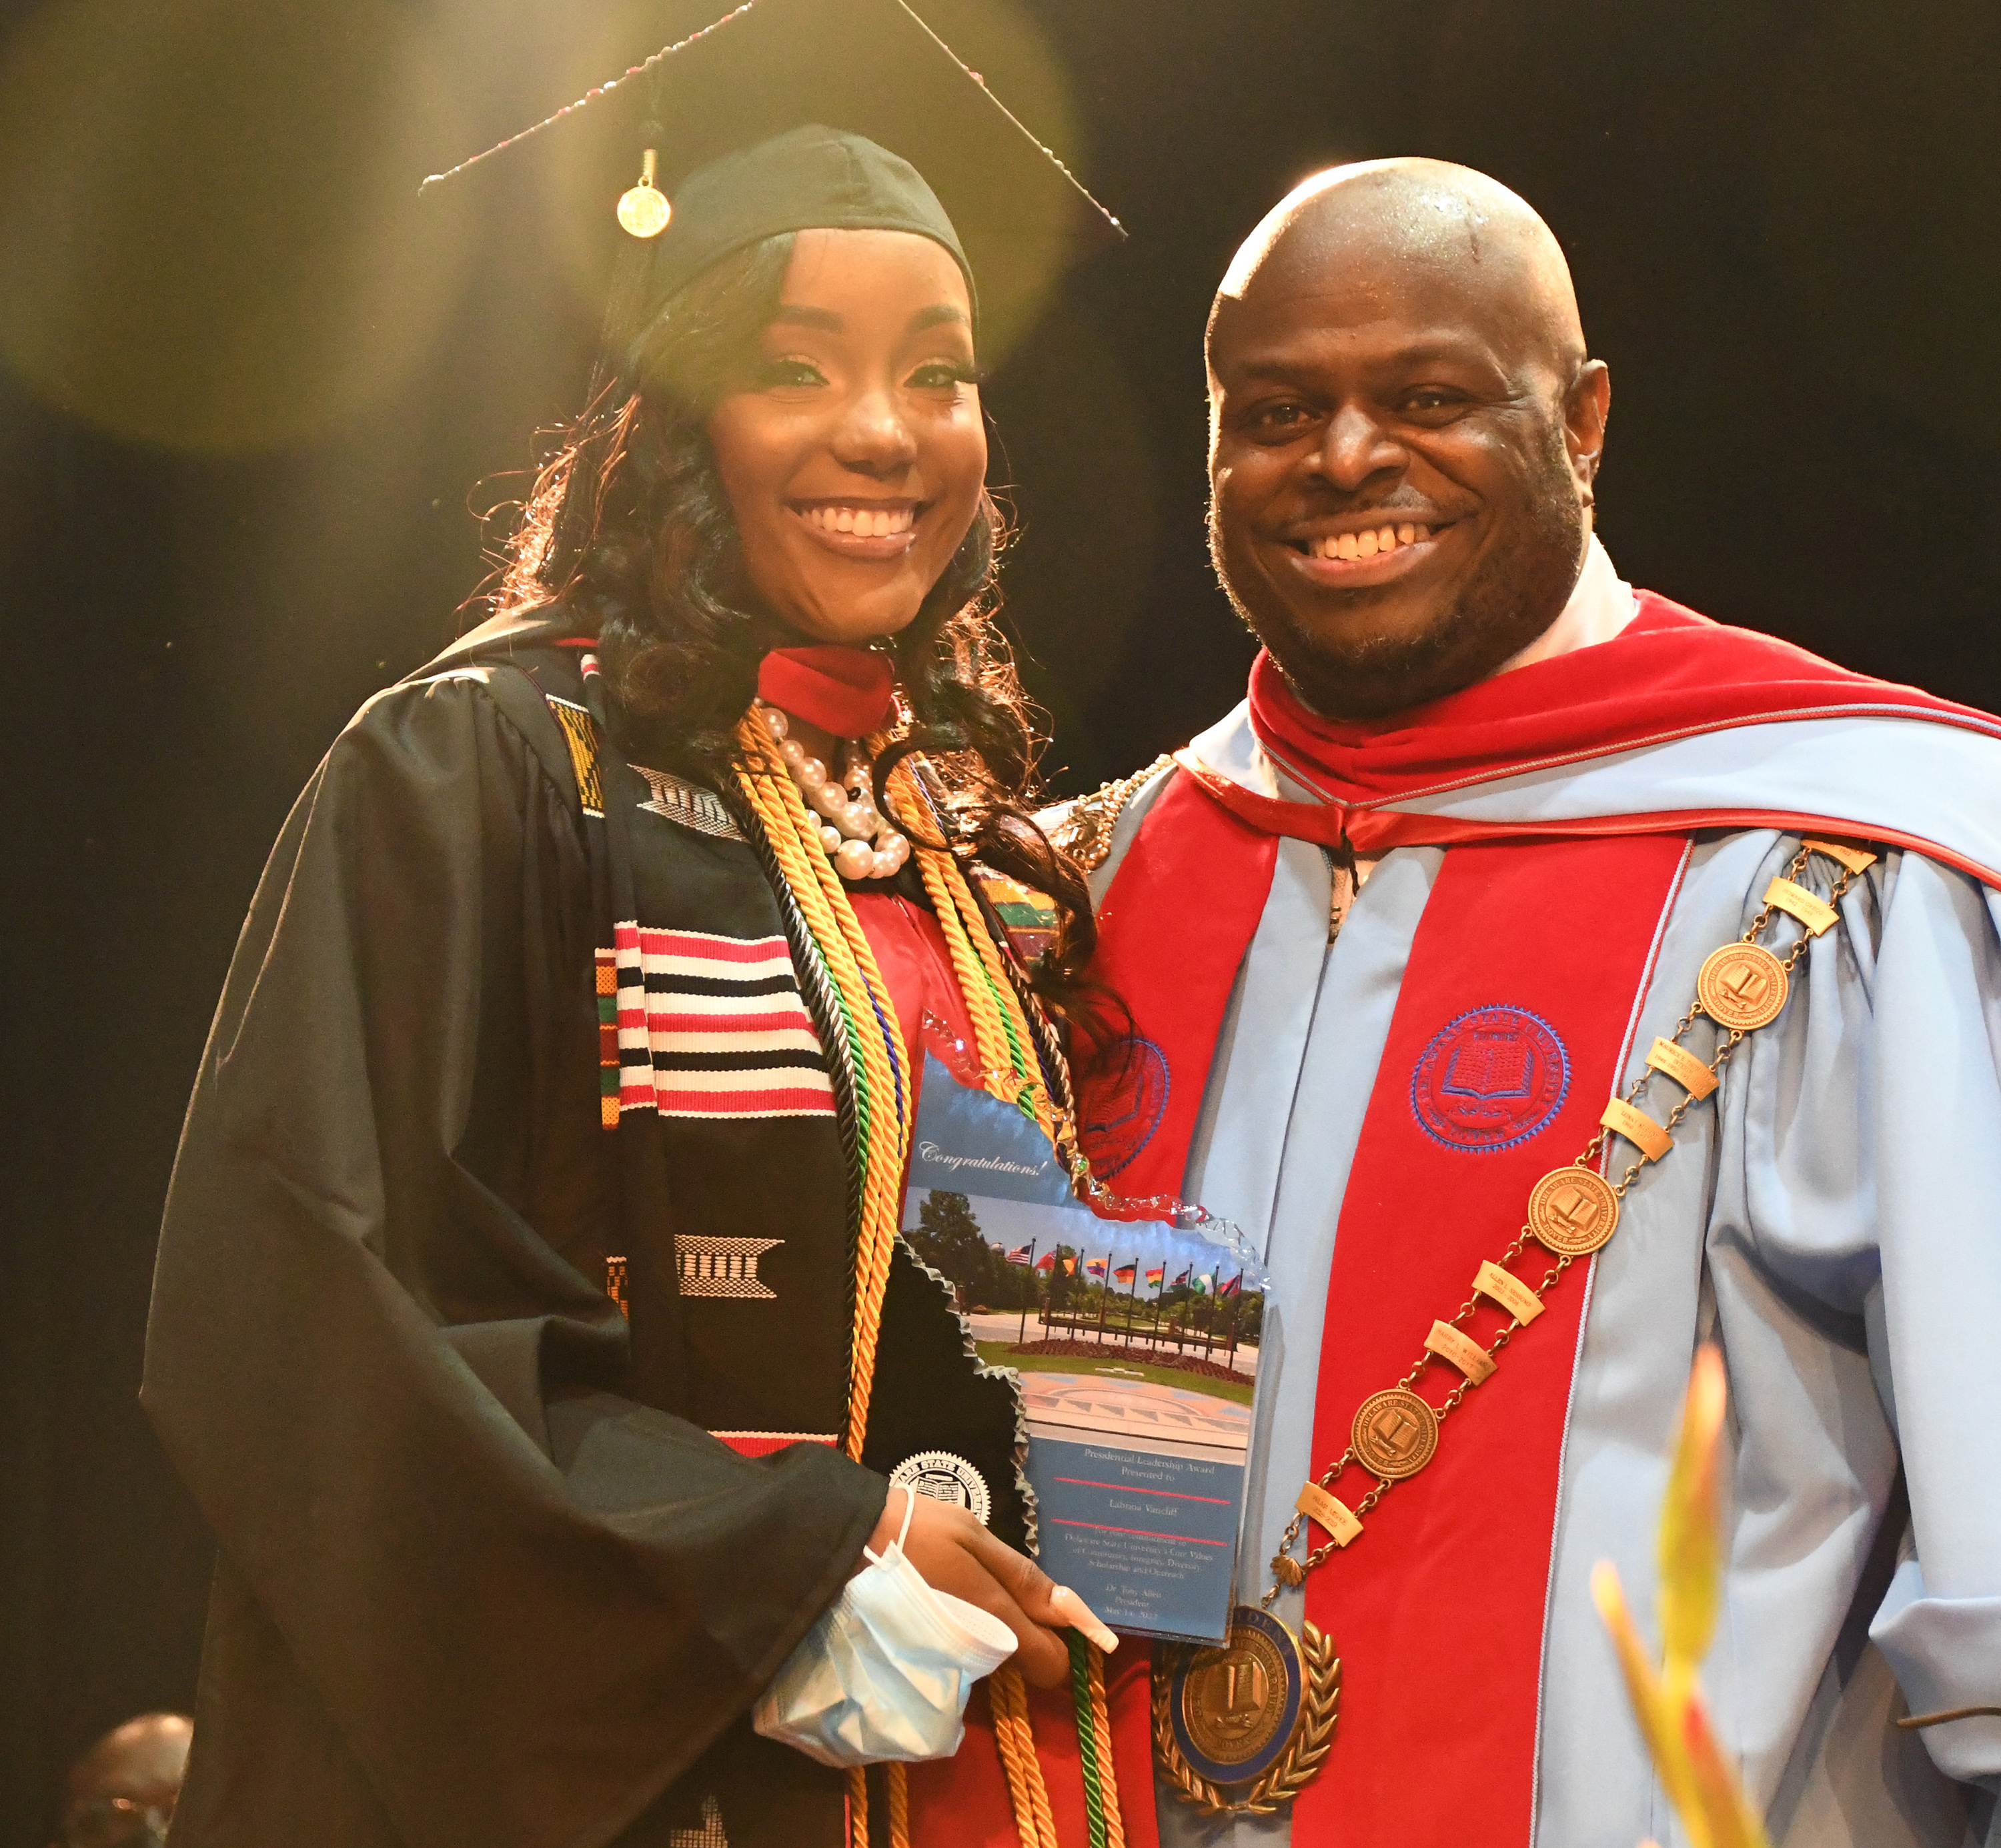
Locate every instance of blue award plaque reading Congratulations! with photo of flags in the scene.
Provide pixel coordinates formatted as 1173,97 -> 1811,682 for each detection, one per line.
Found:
904,1056 -> 1265,1642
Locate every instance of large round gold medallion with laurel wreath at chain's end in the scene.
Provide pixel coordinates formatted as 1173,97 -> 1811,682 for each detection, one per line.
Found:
1153,1604 -> 1341,1816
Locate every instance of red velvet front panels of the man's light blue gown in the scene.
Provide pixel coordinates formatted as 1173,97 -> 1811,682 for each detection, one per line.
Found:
1091,796 -> 1687,1842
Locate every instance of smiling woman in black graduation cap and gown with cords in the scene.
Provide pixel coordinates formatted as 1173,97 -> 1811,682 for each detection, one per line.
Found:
144,0 -> 1153,1848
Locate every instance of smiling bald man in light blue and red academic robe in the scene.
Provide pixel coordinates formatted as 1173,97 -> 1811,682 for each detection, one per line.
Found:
1055,160 -> 2001,1848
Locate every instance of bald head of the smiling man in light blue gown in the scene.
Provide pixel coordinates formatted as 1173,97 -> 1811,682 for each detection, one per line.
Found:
1209,160 -> 1609,718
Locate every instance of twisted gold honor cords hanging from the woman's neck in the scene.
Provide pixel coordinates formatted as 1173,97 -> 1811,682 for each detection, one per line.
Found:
736,712 -> 1125,1848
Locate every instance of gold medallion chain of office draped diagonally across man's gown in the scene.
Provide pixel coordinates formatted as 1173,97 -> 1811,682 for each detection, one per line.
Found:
1153,840 -> 1875,1814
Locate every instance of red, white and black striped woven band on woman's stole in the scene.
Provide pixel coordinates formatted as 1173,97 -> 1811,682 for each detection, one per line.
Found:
614,924 -> 834,1116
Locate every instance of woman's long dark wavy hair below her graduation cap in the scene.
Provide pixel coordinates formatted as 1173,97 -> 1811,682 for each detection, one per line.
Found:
494,234 -> 1117,1044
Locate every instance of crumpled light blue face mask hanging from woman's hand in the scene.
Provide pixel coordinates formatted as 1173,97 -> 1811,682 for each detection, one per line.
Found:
752,1490 -> 1015,1766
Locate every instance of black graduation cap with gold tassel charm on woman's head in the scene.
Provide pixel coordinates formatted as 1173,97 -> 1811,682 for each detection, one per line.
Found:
424,0 -> 1125,358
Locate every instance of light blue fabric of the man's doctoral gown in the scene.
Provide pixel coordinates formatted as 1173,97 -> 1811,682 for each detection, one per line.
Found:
1095,708 -> 2001,1848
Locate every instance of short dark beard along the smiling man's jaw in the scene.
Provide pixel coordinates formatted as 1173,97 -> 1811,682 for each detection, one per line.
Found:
1209,432 -> 1585,720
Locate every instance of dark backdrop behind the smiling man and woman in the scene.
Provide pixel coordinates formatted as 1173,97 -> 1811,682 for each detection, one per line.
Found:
0,0 -> 2001,1848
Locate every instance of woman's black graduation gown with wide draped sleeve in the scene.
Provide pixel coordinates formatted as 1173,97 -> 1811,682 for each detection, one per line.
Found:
142,626 -> 1031,1848
